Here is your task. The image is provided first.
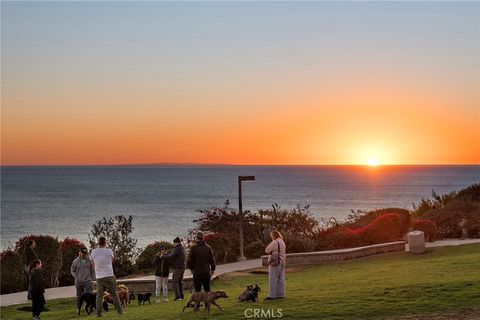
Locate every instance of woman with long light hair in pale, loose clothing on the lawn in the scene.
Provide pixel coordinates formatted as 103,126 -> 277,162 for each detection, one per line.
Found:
265,230 -> 286,300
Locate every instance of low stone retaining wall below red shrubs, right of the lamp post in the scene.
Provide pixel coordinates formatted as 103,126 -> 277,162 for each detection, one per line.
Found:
262,241 -> 405,266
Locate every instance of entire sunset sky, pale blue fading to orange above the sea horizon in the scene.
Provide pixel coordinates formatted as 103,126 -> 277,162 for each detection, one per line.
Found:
1,1 -> 480,165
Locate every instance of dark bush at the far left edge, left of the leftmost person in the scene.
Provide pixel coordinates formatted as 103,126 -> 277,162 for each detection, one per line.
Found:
0,249 -> 25,294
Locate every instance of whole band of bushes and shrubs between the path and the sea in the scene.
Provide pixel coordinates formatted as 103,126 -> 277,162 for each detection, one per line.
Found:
0,184 -> 480,294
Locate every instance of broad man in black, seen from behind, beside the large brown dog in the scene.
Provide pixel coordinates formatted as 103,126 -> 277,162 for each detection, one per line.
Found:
187,231 -> 215,292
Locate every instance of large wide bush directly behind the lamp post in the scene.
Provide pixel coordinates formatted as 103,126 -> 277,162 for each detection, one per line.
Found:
187,200 -> 318,263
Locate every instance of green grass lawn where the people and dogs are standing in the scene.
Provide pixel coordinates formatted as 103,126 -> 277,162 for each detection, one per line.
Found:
1,244 -> 480,320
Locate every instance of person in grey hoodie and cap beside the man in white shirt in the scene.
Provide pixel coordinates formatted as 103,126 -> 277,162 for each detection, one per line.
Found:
70,247 -> 95,314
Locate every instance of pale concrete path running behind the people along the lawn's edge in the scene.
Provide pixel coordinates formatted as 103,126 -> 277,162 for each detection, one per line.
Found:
0,239 -> 480,307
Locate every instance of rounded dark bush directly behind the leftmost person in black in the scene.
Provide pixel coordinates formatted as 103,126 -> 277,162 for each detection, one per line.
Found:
15,235 -> 62,288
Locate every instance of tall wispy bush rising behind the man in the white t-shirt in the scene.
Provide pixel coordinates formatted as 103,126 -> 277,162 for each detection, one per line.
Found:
88,215 -> 138,277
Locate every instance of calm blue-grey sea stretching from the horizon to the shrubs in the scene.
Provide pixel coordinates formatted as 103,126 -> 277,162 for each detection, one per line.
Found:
1,166 -> 480,248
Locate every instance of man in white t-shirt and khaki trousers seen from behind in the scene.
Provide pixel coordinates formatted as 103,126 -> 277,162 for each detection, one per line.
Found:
91,237 -> 123,317
